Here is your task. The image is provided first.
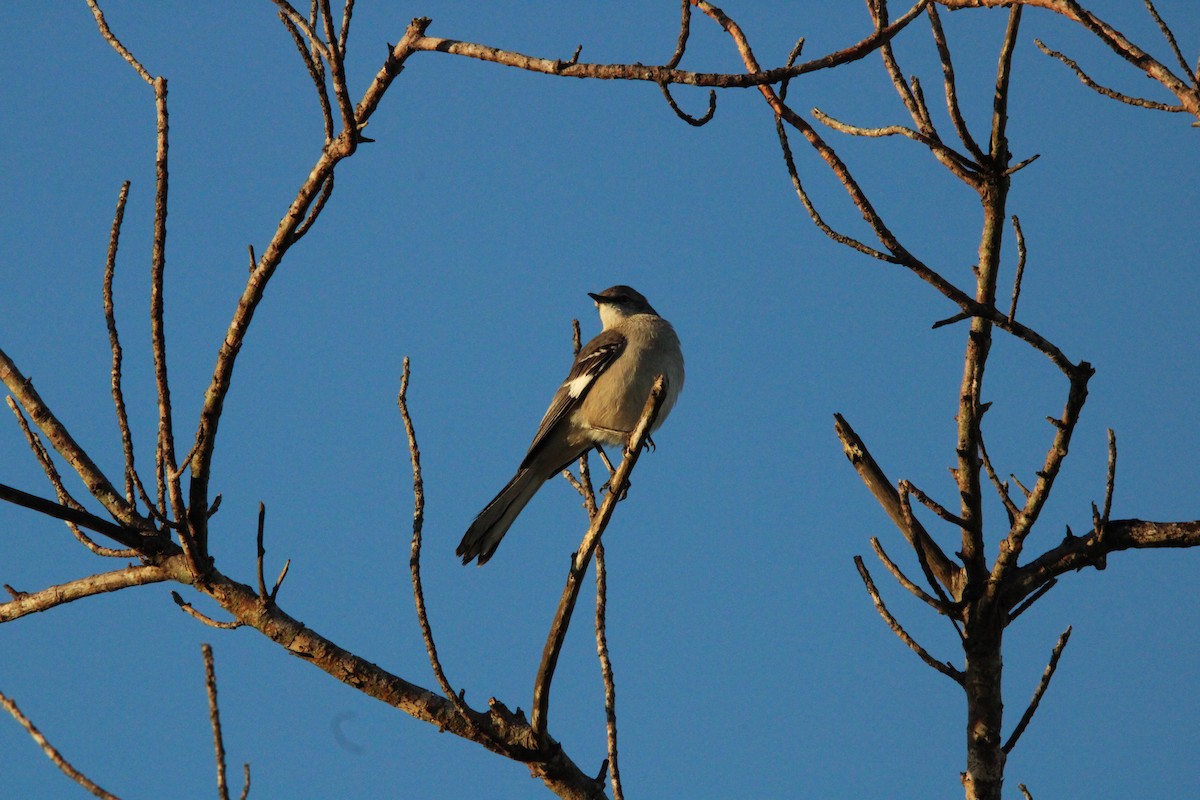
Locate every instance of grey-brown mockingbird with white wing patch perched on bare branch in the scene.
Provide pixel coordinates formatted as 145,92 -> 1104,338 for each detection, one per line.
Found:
456,285 -> 683,565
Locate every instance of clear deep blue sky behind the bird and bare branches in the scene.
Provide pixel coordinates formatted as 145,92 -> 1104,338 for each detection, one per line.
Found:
0,0 -> 1200,799
